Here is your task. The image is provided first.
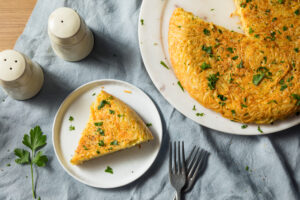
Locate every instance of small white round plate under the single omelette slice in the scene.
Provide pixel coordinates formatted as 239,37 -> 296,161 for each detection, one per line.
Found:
52,80 -> 162,188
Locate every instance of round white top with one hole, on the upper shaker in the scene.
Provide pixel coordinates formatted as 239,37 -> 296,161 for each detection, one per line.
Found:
48,7 -> 80,39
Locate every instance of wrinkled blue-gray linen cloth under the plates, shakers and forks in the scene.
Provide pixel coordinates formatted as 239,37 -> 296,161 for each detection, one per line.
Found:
0,0 -> 300,200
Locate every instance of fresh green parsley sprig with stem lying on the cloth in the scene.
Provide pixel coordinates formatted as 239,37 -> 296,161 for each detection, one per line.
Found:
14,126 -> 48,199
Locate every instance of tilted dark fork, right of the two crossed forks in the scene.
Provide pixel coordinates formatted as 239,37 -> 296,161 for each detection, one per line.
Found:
174,146 -> 209,200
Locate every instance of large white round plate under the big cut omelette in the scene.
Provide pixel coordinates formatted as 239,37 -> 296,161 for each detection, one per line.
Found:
138,0 -> 300,135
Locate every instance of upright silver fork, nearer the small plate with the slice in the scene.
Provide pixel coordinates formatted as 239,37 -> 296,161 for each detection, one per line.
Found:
169,141 -> 186,200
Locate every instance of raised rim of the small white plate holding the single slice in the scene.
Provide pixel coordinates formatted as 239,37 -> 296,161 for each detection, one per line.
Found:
51,79 -> 163,189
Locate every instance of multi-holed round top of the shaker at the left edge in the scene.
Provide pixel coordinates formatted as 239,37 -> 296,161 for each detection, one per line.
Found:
0,50 -> 26,81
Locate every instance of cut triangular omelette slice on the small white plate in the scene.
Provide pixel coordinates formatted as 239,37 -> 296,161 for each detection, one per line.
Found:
71,90 -> 153,165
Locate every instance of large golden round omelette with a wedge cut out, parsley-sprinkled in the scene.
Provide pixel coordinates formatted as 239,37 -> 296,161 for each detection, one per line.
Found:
168,6 -> 300,124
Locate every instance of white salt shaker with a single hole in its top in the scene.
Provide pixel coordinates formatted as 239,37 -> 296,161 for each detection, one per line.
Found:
48,7 -> 94,61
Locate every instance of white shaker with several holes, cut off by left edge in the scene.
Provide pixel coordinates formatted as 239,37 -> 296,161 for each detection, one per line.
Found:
0,50 -> 44,100
